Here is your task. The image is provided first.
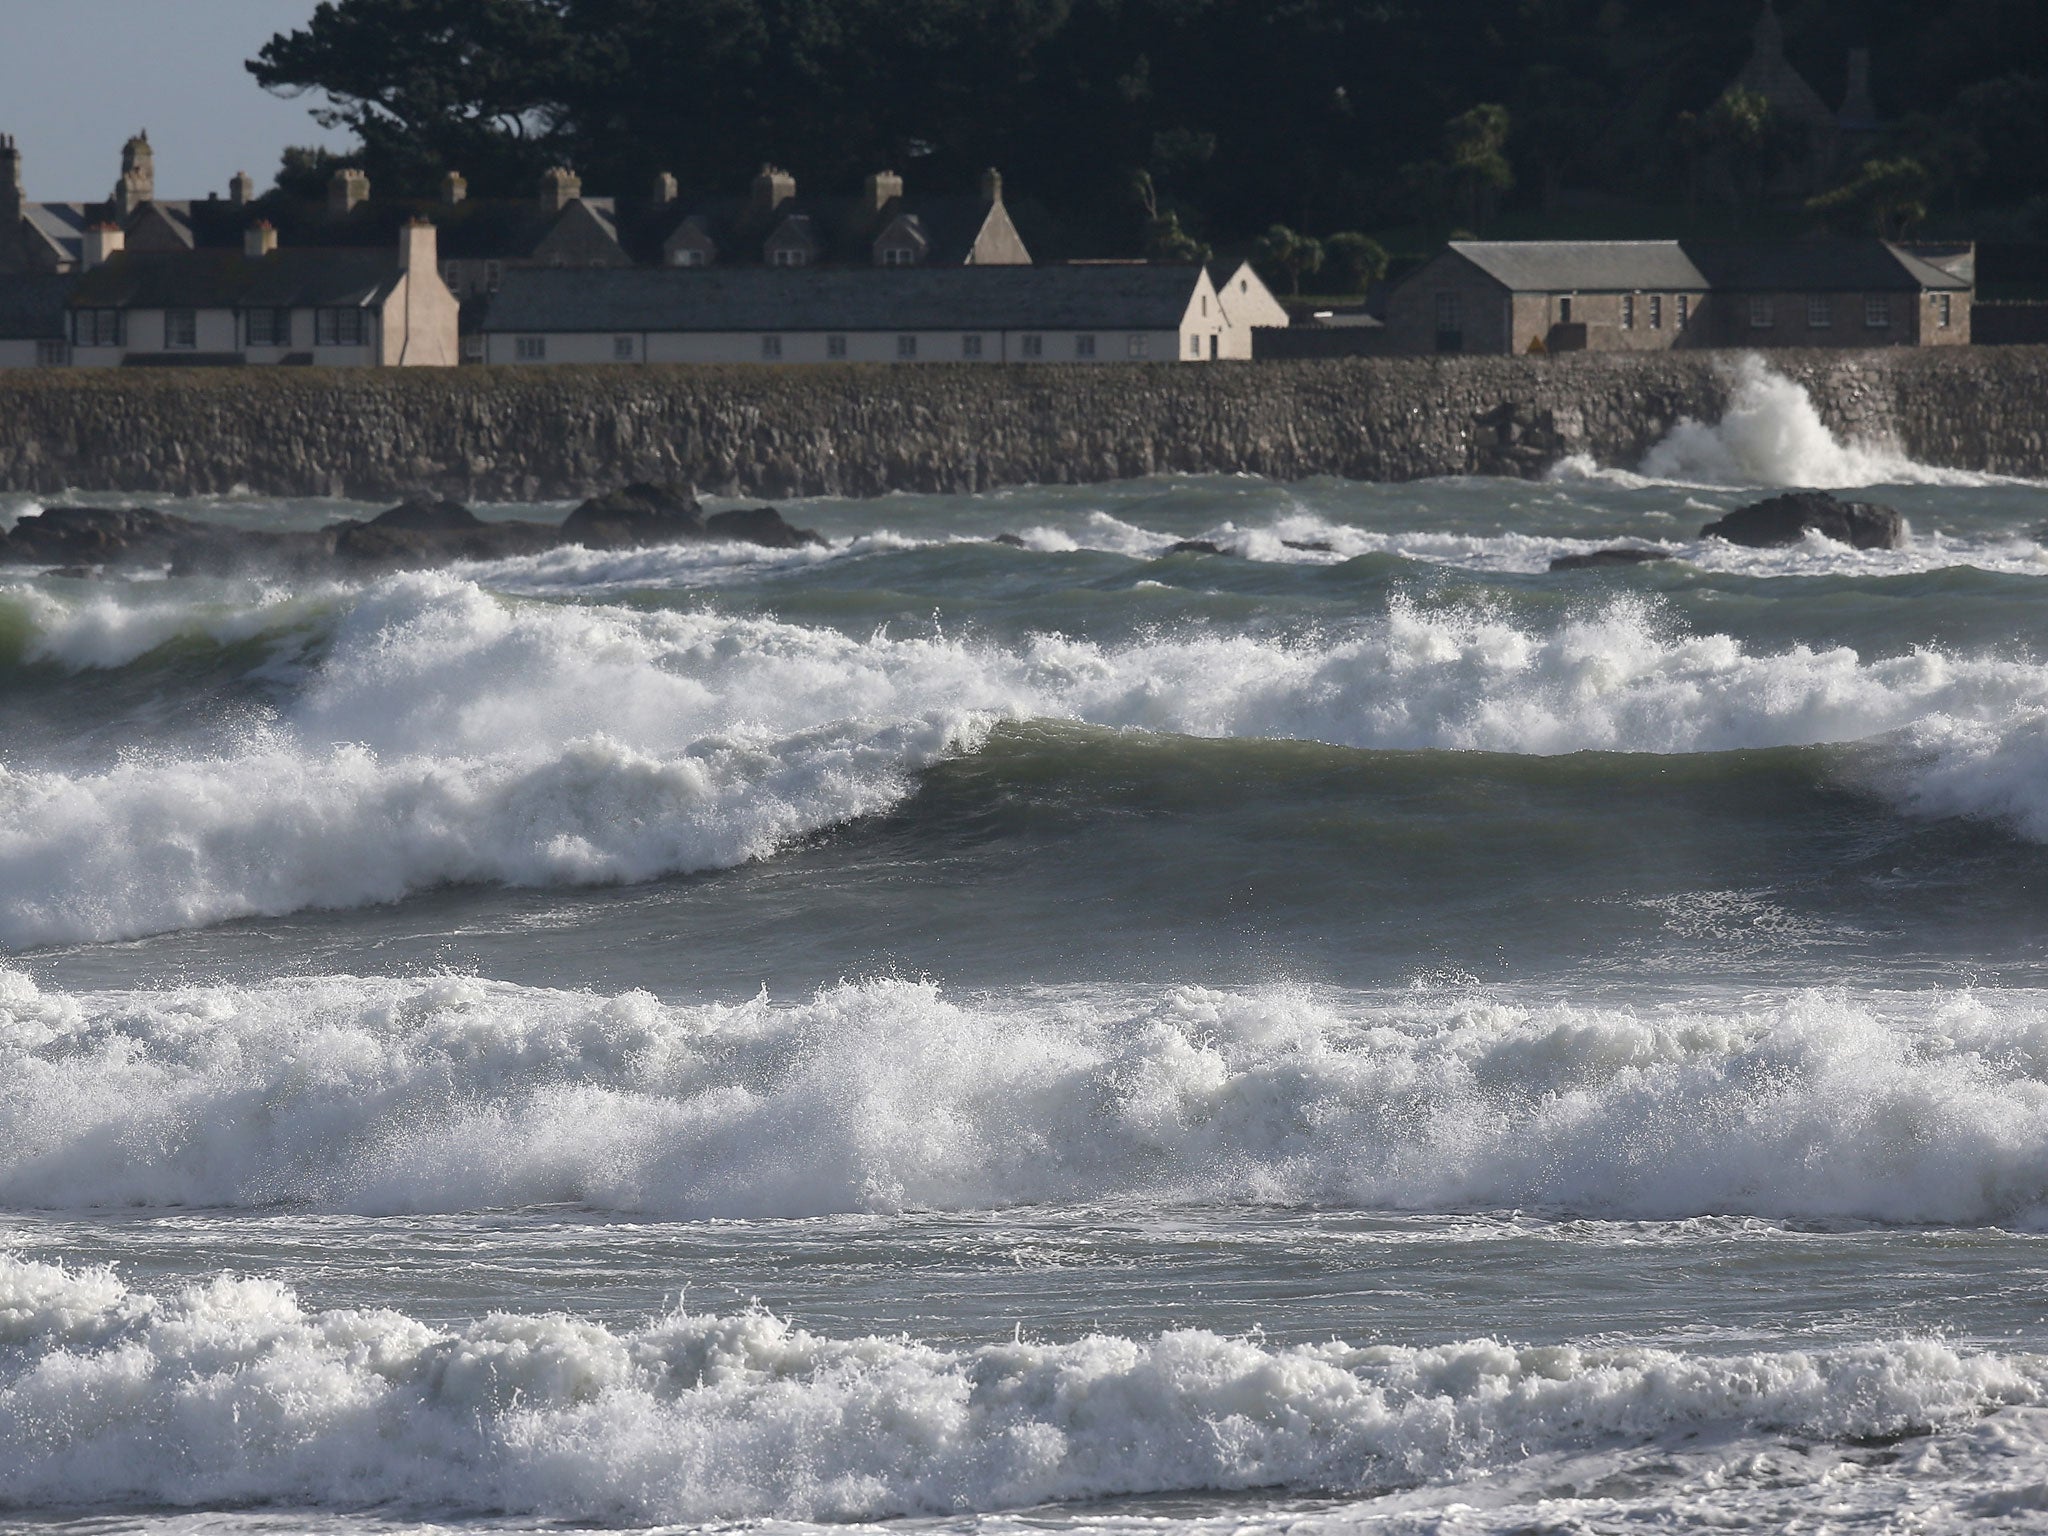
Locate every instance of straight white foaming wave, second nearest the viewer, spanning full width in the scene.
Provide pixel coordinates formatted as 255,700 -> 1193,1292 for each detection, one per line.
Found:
0,971 -> 2048,1229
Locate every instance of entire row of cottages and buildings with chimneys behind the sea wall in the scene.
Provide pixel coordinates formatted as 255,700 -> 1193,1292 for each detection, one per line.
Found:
0,135 -> 1972,367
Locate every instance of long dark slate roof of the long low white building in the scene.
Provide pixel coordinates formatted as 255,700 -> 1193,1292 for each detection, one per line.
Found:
479,264 -> 1200,334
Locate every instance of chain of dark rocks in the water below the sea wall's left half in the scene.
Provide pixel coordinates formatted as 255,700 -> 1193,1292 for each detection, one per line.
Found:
0,485 -> 823,575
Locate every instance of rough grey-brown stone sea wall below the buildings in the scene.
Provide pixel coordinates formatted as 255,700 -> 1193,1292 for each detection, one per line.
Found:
0,346 -> 2048,502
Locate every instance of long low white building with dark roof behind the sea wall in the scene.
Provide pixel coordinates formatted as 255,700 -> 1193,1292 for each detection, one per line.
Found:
465,262 -> 1249,365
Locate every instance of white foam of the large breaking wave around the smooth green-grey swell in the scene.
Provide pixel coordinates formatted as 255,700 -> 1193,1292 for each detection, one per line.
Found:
0,573 -> 2048,948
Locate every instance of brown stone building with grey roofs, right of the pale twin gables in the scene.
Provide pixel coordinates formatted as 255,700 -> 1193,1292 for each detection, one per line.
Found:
1386,240 -> 1972,354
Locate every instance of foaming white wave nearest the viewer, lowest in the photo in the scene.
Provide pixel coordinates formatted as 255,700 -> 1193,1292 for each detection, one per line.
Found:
0,1255 -> 2048,1522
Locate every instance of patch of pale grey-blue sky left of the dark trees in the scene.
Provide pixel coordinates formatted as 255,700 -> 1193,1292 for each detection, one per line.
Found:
0,0 -> 348,203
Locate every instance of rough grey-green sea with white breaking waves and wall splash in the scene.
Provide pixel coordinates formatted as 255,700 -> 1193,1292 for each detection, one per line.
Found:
0,362 -> 2048,1536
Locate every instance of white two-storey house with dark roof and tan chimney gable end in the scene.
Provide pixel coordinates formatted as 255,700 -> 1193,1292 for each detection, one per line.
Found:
68,221 -> 461,367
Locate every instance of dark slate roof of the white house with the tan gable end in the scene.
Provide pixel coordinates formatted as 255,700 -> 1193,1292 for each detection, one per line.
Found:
70,250 -> 399,309
